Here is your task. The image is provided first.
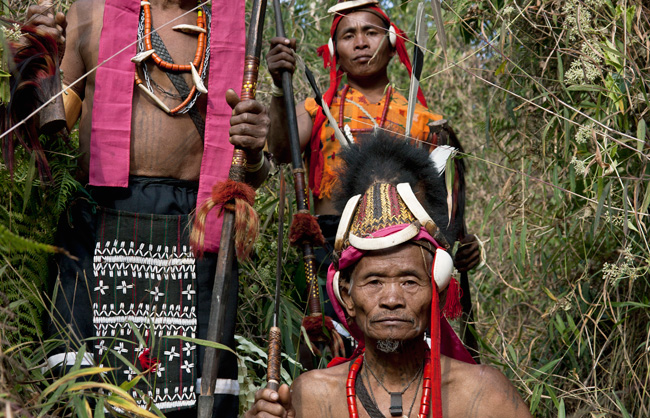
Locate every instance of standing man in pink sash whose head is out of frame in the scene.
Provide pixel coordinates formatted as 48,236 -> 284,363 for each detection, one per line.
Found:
28,0 -> 269,418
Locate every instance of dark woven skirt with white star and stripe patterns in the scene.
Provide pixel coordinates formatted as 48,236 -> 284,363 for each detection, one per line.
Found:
48,178 -> 239,417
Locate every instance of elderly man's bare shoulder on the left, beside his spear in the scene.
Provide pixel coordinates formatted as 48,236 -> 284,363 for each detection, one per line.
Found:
291,363 -> 350,418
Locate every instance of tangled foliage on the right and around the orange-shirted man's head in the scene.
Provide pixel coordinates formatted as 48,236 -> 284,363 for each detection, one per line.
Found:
253,0 -> 650,417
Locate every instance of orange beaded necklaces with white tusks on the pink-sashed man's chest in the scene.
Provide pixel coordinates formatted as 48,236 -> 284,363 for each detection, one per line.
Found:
135,0 -> 210,115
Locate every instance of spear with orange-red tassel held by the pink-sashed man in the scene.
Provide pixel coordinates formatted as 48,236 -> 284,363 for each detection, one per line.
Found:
195,0 -> 266,418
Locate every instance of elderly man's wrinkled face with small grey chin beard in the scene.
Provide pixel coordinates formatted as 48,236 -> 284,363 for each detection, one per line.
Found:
341,244 -> 432,343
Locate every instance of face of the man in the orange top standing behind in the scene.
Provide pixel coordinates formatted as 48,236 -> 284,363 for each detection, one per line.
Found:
336,11 -> 395,77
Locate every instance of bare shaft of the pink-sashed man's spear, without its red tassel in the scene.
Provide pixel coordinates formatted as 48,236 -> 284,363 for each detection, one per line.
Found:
198,0 -> 266,418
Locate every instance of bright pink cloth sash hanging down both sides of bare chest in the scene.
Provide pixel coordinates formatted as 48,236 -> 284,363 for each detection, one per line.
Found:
89,0 -> 246,252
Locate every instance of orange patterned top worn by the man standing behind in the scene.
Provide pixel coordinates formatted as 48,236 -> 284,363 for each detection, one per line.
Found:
305,87 -> 442,199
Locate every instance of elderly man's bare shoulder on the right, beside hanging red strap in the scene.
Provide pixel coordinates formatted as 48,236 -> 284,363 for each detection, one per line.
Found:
442,358 -> 531,418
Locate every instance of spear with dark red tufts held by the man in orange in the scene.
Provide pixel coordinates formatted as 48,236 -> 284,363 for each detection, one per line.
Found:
273,0 -> 340,354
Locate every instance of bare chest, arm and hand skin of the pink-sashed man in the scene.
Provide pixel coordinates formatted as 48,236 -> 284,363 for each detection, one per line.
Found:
30,0 -> 268,183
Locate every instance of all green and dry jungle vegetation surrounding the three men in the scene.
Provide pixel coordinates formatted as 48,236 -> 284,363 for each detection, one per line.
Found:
0,0 -> 650,418
